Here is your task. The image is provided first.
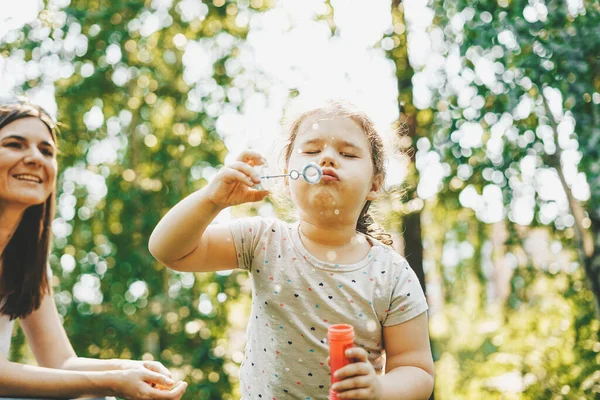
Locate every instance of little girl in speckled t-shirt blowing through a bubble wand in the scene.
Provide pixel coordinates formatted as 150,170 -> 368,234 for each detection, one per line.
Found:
150,103 -> 434,399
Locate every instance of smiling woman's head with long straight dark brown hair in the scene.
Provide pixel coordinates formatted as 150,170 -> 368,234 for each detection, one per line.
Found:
0,104 -> 58,322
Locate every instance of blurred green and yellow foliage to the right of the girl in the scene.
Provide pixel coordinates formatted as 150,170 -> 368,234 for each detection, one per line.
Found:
419,0 -> 600,399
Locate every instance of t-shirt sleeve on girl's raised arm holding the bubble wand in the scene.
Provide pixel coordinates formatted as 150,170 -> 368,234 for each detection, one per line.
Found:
229,217 -> 267,271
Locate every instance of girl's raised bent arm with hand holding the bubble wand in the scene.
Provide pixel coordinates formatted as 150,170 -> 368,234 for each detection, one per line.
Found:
148,151 -> 269,272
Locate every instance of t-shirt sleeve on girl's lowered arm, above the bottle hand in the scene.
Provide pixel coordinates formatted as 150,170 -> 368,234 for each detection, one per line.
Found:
383,259 -> 429,326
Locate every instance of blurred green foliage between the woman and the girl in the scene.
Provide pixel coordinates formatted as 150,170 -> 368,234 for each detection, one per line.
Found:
0,0 -> 269,400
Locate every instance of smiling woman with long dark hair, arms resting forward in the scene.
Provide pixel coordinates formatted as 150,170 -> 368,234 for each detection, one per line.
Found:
0,101 -> 186,400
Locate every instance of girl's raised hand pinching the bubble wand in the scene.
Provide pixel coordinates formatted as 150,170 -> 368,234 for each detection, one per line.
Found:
206,150 -> 269,208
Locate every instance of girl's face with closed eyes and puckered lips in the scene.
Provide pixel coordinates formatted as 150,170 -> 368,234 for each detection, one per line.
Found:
288,113 -> 380,223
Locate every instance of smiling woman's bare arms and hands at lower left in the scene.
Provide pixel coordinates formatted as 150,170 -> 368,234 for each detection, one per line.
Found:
0,295 -> 186,399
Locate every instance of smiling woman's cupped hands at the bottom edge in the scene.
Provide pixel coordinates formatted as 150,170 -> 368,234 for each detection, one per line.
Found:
109,363 -> 187,400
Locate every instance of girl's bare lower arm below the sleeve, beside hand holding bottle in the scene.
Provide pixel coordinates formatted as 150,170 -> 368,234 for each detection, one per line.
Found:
379,313 -> 435,400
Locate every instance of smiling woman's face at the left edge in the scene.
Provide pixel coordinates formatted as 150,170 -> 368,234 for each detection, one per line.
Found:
0,117 -> 58,207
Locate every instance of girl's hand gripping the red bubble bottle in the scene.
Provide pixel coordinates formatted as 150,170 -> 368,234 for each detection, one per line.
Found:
331,347 -> 381,400
